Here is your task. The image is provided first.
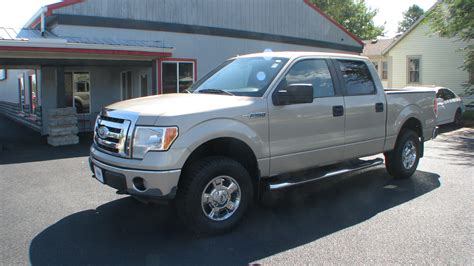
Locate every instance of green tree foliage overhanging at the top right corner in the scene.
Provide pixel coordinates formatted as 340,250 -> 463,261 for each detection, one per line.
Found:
427,0 -> 474,95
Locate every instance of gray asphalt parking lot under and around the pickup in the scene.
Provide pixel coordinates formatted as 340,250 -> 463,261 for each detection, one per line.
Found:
0,116 -> 474,265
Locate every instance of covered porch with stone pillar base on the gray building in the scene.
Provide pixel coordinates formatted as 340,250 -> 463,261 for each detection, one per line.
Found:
0,28 -> 174,145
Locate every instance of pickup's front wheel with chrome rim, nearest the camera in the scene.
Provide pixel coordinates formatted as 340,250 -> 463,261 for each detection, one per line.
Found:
175,156 -> 254,235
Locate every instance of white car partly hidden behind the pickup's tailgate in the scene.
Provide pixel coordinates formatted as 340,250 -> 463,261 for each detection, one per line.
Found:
435,87 -> 465,126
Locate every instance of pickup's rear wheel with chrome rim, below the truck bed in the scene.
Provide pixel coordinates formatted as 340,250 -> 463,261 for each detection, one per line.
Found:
385,129 -> 421,178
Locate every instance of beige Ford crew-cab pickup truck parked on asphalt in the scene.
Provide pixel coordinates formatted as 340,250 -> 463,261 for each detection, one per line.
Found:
90,52 -> 437,234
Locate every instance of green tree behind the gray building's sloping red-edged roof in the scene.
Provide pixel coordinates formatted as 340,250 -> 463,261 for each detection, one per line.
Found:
311,0 -> 385,40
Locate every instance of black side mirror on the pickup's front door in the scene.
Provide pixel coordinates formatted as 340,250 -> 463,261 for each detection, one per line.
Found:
272,84 -> 314,106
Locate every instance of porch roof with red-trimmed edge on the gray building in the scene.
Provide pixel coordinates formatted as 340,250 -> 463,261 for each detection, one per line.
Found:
0,27 -> 173,61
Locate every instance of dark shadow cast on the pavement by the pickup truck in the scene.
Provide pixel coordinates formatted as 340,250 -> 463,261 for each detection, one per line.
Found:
30,167 -> 440,265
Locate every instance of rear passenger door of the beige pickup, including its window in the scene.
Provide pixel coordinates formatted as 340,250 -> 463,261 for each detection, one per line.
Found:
334,60 -> 387,159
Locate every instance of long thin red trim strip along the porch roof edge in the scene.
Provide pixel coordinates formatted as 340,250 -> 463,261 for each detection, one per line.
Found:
0,46 -> 172,57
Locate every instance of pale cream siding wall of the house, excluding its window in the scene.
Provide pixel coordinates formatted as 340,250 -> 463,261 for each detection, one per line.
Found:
388,23 -> 469,94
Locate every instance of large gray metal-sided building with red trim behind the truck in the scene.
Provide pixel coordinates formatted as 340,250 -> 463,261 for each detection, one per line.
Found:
0,0 -> 363,144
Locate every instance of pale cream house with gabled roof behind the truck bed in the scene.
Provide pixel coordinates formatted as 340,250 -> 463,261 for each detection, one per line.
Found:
382,6 -> 472,103
